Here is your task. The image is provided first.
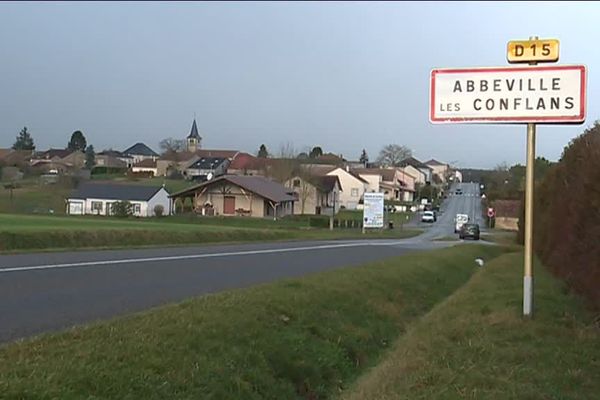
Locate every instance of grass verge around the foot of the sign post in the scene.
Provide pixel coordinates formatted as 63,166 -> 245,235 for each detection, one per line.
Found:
341,253 -> 600,400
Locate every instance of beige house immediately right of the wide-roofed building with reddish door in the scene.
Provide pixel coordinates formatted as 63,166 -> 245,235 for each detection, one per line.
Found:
285,175 -> 341,215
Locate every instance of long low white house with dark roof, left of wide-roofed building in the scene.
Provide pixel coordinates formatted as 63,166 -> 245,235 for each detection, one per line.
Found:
67,183 -> 171,217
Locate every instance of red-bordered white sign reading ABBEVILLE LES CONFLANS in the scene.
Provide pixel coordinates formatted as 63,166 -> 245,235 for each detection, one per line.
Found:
429,65 -> 587,123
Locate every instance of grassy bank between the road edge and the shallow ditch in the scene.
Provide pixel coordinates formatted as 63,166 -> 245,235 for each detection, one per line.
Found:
0,246 -> 514,400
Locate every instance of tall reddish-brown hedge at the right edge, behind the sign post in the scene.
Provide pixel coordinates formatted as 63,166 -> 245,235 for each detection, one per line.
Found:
519,122 -> 600,309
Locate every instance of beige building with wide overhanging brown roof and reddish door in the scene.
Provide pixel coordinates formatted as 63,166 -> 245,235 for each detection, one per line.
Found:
171,175 -> 297,219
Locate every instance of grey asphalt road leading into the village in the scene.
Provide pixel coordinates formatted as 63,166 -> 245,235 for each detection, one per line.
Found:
0,184 -> 480,342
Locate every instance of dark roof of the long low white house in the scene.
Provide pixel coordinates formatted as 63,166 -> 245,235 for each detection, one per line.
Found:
70,182 -> 162,201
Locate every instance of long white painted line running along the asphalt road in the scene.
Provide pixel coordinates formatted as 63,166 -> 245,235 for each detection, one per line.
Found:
0,241 -> 400,273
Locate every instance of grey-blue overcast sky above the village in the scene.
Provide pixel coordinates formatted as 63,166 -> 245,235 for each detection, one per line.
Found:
0,2 -> 600,168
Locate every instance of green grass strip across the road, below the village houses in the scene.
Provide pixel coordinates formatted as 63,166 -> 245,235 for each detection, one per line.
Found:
0,214 -> 420,251
